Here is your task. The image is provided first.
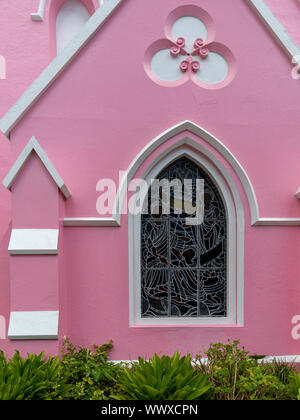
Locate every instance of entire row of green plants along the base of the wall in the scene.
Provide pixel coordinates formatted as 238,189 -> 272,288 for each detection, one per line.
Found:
0,339 -> 300,400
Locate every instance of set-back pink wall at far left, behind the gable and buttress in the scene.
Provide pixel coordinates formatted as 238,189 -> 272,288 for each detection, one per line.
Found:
0,0 -> 50,351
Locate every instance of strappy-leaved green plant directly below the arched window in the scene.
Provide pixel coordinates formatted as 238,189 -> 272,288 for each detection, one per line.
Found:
117,352 -> 210,400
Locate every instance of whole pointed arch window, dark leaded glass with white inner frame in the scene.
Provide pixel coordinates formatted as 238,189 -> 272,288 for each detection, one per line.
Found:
128,145 -> 244,326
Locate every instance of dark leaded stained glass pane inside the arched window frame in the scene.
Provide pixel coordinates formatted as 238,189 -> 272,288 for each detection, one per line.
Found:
141,157 -> 227,318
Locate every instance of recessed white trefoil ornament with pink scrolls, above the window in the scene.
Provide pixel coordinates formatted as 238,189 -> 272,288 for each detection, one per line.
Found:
144,6 -> 236,89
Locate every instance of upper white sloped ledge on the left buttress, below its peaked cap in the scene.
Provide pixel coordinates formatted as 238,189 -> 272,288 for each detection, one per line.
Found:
8,229 -> 59,255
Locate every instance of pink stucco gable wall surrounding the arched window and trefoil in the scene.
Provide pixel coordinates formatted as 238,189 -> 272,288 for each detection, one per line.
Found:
0,0 -> 300,359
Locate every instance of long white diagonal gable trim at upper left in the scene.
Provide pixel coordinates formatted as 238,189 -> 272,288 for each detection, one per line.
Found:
0,0 -> 123,136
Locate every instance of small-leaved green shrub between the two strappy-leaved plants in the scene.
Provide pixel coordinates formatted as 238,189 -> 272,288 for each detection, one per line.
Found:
48,339 -> 122,400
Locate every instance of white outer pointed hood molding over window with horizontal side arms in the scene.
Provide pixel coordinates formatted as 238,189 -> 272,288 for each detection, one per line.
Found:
64,121 -> 300,227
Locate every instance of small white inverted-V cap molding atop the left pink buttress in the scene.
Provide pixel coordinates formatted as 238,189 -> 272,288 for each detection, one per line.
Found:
3,137 -> 71,199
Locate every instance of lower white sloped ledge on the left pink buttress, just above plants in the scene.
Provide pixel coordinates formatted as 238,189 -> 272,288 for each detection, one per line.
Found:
8,311 -> 59,340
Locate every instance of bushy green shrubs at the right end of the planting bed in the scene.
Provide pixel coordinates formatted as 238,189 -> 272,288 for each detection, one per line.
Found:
197,341 -> 297,400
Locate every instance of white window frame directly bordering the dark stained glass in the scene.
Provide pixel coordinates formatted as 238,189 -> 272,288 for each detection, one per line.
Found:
128,143 -> 244,326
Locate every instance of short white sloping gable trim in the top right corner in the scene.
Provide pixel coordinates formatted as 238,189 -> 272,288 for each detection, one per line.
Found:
246,0 -> 300,59
